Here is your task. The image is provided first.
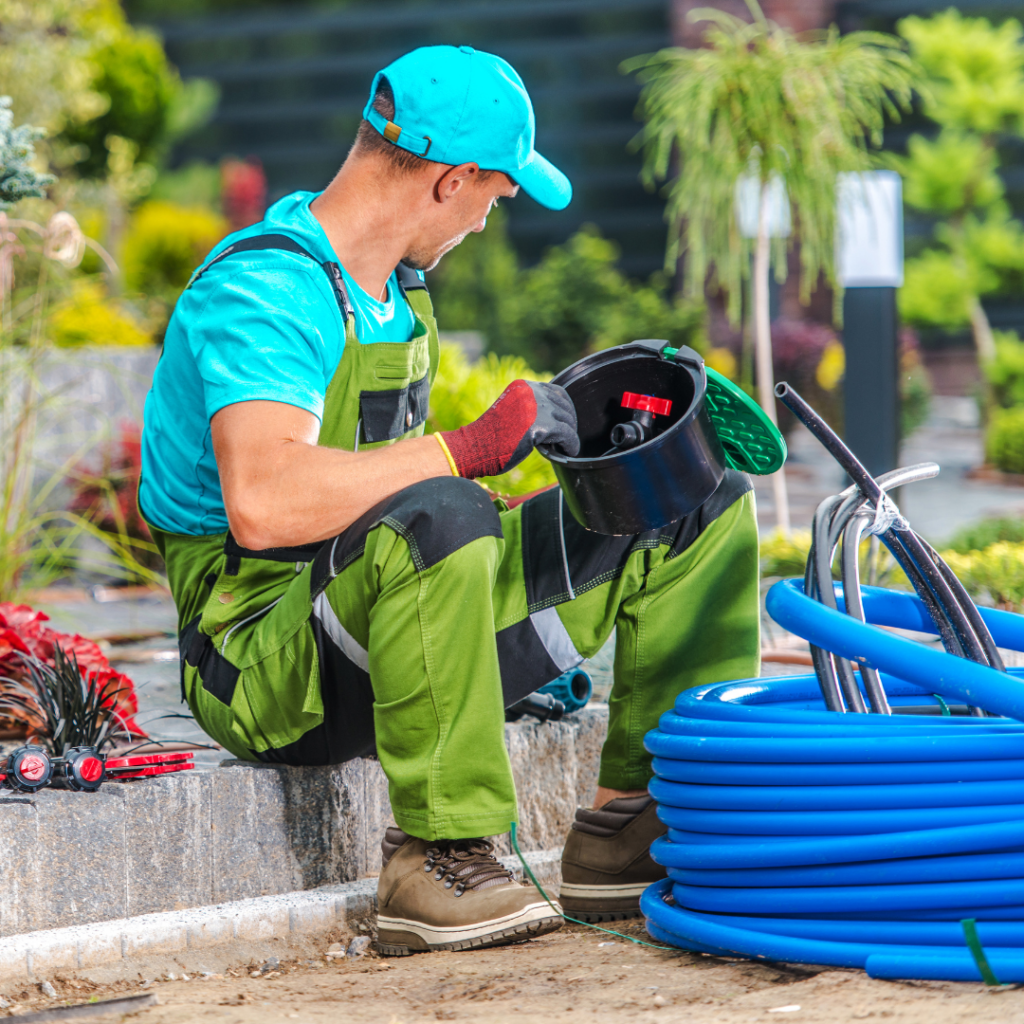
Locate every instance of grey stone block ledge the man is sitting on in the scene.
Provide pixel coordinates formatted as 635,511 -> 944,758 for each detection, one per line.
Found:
0,706 -> 607,936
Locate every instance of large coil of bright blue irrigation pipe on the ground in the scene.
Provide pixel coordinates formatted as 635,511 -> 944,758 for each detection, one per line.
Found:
641,580 -> 1024,983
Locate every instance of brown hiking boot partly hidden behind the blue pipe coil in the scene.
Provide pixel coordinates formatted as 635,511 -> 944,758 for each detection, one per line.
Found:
559,796 -> 668,922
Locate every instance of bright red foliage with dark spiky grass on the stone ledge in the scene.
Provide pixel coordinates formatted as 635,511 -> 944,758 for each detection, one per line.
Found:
0,601 -> 147,754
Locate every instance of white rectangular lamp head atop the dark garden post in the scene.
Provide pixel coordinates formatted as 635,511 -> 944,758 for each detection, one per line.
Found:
836,171 -> 903,288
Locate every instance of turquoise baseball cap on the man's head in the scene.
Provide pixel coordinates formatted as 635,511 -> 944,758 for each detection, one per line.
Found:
362,46 -> 572,210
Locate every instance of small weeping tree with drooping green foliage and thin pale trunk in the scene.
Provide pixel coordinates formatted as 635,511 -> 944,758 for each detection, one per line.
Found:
624,6 -> 919,531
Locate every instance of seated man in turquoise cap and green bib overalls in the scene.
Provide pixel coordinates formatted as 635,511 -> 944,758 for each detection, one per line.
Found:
140,46 -> 759,953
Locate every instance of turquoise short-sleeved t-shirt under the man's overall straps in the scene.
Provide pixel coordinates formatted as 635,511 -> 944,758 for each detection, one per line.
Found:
139,193 -> 415,536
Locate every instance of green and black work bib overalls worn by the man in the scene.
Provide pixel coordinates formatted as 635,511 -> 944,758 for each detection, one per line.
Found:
153,236 -> 760,840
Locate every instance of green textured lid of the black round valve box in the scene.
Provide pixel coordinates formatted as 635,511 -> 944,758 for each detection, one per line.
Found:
662,348 -> 787,476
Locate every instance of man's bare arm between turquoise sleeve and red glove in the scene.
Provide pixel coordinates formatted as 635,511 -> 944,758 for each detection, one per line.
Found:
211,401 -> 452,550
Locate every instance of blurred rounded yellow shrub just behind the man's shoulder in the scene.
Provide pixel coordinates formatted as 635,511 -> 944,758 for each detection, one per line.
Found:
121,202 -> 227,302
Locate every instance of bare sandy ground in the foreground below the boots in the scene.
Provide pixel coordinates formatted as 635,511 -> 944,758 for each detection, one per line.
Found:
6,923 -> 1024,1024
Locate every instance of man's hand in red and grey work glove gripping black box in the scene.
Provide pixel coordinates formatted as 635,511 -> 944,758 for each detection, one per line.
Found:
441,381 -> 580,479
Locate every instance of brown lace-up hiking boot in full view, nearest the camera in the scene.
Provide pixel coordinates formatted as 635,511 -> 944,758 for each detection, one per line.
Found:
377,828 -> 562,956
